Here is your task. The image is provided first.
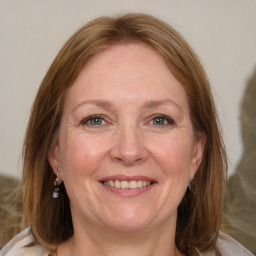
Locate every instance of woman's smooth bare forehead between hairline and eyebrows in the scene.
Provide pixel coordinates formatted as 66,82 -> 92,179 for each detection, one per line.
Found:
66,42 -> 187,111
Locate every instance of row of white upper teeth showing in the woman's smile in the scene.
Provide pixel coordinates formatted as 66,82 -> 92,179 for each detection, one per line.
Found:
103,180 -> 151,189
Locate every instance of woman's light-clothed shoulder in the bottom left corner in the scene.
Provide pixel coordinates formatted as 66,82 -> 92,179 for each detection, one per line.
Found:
0,228 -> 48,256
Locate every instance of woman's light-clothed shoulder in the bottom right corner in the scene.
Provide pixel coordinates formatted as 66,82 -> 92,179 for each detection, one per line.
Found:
199,232 -> 253,256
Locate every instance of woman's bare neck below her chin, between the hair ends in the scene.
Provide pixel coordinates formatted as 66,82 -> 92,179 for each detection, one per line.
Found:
58,218 -> 181,256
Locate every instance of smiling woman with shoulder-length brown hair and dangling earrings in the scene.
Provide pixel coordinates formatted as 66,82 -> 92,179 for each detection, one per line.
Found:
2,14 -> 251,256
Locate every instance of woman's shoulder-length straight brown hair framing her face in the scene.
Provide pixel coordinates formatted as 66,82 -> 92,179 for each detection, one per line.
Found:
22,14 -> 226,255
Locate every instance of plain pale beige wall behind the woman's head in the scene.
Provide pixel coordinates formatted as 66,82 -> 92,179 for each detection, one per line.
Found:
0,0 -> 256,176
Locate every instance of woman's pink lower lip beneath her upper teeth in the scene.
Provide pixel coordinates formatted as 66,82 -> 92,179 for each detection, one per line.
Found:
102,183 -> 155,197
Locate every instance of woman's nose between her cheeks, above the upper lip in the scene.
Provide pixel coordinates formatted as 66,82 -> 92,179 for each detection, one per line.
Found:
110,126 -> 147,166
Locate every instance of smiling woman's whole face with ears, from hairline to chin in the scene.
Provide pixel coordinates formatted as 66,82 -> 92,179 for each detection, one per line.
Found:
49,43 -> 204,231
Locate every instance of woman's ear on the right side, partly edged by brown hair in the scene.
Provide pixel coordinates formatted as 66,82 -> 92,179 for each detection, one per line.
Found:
190,132 -> 206,180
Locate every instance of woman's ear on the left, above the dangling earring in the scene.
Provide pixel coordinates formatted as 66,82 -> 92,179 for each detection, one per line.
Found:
47,142 -> 62,184
